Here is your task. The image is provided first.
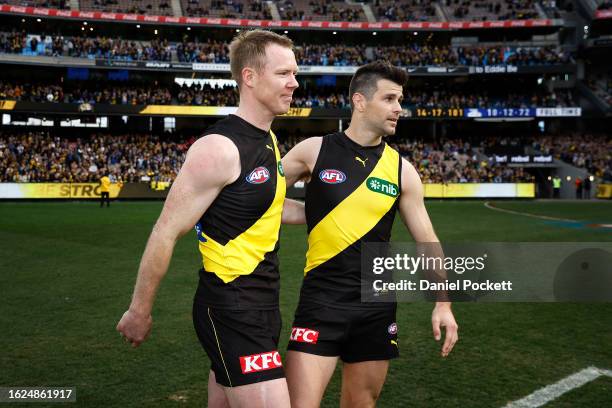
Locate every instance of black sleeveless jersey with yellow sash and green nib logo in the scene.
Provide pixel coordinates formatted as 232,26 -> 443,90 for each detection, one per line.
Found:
300,132 -> 401,308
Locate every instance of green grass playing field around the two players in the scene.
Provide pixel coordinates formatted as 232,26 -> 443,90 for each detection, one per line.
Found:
0,201 -> 612,407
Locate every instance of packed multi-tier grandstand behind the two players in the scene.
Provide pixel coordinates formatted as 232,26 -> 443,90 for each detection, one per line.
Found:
0,0 -> 612,199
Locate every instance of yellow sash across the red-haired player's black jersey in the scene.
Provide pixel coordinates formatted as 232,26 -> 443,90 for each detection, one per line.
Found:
199,132 -> 287,283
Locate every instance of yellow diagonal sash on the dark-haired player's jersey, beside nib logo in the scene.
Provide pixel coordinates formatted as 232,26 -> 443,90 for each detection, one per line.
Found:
304,146 -> 400,275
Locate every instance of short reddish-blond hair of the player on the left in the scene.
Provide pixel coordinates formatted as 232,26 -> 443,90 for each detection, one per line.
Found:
229,30 -> 293,87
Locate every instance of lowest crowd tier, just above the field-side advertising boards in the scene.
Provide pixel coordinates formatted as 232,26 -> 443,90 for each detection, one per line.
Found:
0,132 -> 612,183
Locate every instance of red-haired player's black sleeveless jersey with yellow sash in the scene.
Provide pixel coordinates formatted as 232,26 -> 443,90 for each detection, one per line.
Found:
196,115 -> 286,309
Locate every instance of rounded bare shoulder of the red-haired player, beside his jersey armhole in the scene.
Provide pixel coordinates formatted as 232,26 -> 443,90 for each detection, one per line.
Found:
183,134 -> 240,185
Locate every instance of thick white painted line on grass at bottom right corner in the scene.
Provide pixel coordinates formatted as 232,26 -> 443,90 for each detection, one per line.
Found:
504,366 -> 612,408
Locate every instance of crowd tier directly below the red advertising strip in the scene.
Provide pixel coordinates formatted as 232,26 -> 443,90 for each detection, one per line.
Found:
0,32 -> 572,66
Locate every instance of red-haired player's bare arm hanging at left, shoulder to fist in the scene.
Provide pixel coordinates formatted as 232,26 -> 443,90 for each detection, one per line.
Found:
117,135 -> 240,347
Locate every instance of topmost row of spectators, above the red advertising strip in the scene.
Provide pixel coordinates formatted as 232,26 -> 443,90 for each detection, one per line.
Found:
0,0 -> 544,21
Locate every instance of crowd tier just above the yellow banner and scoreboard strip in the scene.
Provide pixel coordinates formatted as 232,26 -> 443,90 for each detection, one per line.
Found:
0,81 -> 577,108
